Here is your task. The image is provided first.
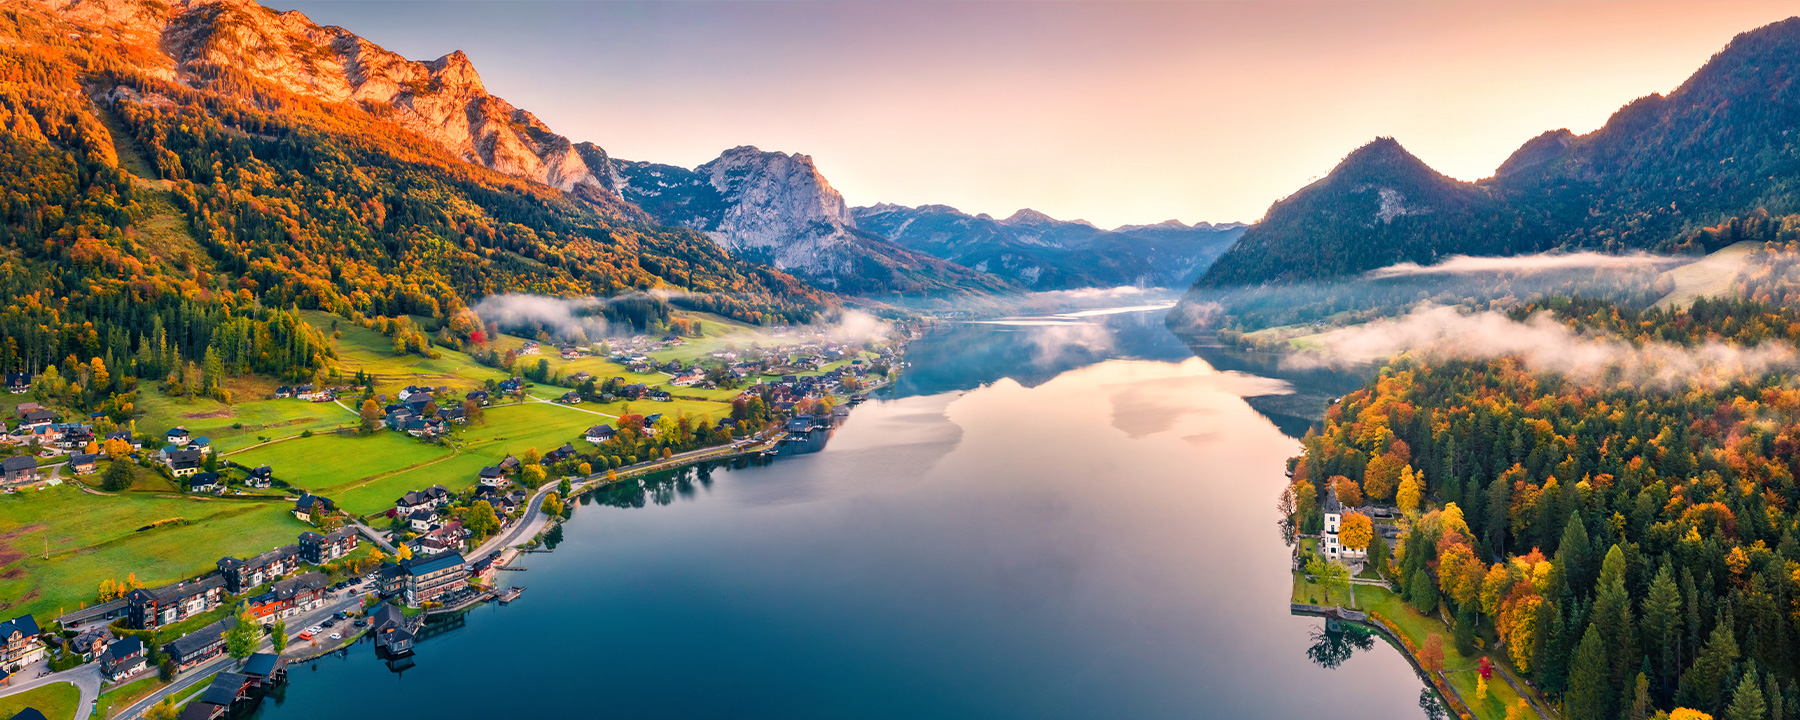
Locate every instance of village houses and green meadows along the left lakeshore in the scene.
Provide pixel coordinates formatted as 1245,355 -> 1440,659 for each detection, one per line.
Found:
0,307 -> 900,718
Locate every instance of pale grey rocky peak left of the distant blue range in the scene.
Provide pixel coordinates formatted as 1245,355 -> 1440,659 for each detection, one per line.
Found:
616,146 -> 1010,295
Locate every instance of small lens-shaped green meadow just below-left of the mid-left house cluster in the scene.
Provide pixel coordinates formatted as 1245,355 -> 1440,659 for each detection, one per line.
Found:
230,430 -> 450,500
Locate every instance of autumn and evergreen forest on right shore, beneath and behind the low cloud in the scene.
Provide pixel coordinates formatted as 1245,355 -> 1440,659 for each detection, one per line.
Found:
1292,301 -> 1800,720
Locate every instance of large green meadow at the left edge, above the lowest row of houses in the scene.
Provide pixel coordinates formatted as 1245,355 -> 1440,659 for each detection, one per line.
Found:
0,484 -> 308,621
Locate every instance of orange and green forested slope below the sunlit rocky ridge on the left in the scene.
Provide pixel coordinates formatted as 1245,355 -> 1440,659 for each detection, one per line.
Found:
0,2 -> 824,380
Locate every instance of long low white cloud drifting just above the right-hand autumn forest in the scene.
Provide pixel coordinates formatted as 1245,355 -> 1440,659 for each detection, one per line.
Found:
1283,306 -> 1800,389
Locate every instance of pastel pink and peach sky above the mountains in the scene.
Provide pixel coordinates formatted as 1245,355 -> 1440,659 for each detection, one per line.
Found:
265,0 -> 1795,227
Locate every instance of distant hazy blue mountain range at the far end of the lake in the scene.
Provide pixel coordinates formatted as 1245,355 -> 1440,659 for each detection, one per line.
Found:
851,203 -> 1244,290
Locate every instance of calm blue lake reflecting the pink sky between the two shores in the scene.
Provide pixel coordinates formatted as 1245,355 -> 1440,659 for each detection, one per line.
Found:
257,311 -> 1424,720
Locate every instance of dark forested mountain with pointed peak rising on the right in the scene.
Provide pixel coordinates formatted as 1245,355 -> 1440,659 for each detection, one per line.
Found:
1197,18 -> 1800,288
